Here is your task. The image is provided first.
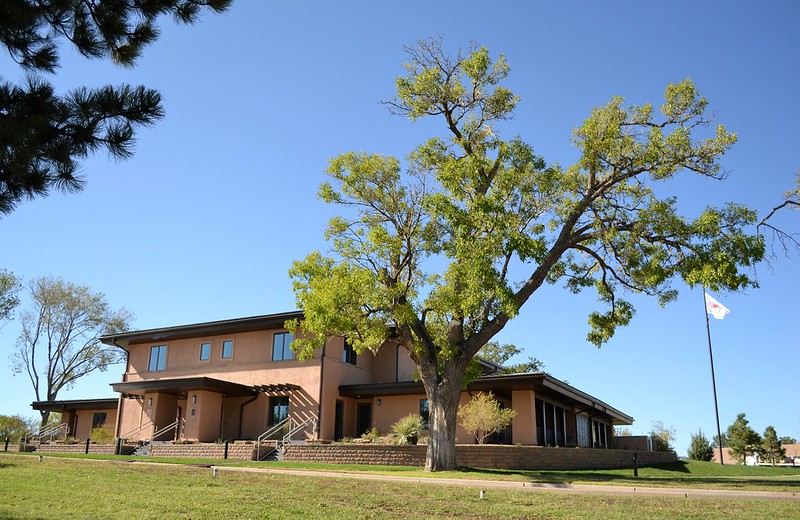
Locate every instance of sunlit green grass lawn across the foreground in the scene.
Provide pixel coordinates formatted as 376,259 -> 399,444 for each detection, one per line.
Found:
0,454 -> 800,520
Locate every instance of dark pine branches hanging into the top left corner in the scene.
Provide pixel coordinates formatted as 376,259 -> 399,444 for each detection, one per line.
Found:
0,0 -> 231,216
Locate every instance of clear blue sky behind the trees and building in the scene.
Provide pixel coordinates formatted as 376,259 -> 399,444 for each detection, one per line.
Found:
0,0 -> 800,454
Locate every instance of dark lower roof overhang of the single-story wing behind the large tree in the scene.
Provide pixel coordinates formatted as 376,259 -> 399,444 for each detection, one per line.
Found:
339,372 -> 633,425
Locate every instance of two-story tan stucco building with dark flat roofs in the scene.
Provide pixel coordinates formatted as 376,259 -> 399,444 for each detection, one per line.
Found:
33,311 -> 633,448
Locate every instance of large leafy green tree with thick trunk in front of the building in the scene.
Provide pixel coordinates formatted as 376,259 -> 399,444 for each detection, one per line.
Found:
290,39 -> 764,471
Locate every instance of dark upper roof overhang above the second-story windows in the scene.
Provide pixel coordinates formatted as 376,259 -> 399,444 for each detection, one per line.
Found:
100,311 -> 303,350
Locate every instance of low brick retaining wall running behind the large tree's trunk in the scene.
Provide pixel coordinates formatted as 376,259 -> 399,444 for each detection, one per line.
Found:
283,444 -> 675,470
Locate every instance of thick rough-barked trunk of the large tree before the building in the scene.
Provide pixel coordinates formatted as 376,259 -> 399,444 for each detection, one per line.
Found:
423,364 -> 463,471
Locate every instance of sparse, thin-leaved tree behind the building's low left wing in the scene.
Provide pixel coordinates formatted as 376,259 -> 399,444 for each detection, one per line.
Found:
11,276 -> 133,425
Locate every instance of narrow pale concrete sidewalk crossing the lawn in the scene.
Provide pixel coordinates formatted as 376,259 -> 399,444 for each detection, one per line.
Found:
212,466 -> 800,501
